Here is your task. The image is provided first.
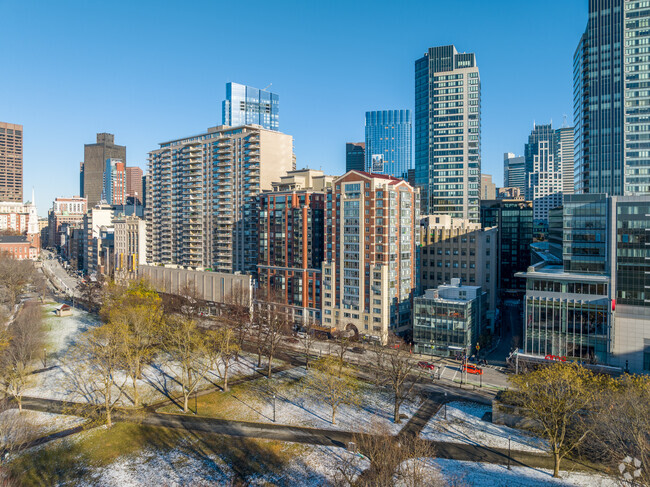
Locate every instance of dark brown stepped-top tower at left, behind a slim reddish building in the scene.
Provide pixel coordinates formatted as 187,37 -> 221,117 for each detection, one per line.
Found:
79,133 -> 126,208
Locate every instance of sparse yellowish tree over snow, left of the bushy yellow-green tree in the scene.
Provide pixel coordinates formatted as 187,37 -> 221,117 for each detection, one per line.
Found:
66,322 -> 129,428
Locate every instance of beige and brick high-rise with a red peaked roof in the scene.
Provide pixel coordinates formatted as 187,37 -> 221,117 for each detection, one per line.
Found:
322,171 -> 419,343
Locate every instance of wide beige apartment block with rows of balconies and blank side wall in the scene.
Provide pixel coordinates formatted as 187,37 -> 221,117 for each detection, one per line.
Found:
146,126 -> 295,273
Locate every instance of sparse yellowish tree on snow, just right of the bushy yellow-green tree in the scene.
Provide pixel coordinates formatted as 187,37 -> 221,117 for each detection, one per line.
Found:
160,315 -> 214,413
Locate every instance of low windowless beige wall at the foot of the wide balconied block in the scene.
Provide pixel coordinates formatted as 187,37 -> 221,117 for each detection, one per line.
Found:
138,265 -> 252,303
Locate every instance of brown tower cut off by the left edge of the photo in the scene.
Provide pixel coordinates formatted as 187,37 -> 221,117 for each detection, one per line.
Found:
0,122 -> 23,203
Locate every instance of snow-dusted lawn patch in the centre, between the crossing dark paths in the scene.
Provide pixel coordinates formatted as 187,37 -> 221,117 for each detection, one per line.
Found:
168,367 -> 421,434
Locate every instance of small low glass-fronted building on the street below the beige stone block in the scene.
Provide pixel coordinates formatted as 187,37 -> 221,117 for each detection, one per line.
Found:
413,279 -> 485,357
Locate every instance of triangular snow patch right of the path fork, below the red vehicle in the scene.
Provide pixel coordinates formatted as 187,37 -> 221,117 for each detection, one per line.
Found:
421,401 -> 548,453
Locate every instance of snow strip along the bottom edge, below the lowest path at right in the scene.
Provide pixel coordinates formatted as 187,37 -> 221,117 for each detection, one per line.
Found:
431,459 -> 620,487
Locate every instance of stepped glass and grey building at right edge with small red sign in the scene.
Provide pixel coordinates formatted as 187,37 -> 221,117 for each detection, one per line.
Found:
518,194 -> 650,373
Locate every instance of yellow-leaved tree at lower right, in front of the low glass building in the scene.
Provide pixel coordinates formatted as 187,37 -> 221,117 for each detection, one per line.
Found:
510,364 -> 595,477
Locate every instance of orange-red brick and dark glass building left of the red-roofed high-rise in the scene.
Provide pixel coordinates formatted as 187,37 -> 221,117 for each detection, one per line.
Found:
257,169 -> 334,324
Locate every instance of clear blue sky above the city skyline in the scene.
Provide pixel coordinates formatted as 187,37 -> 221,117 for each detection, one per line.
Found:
0,0 -> 588,216
